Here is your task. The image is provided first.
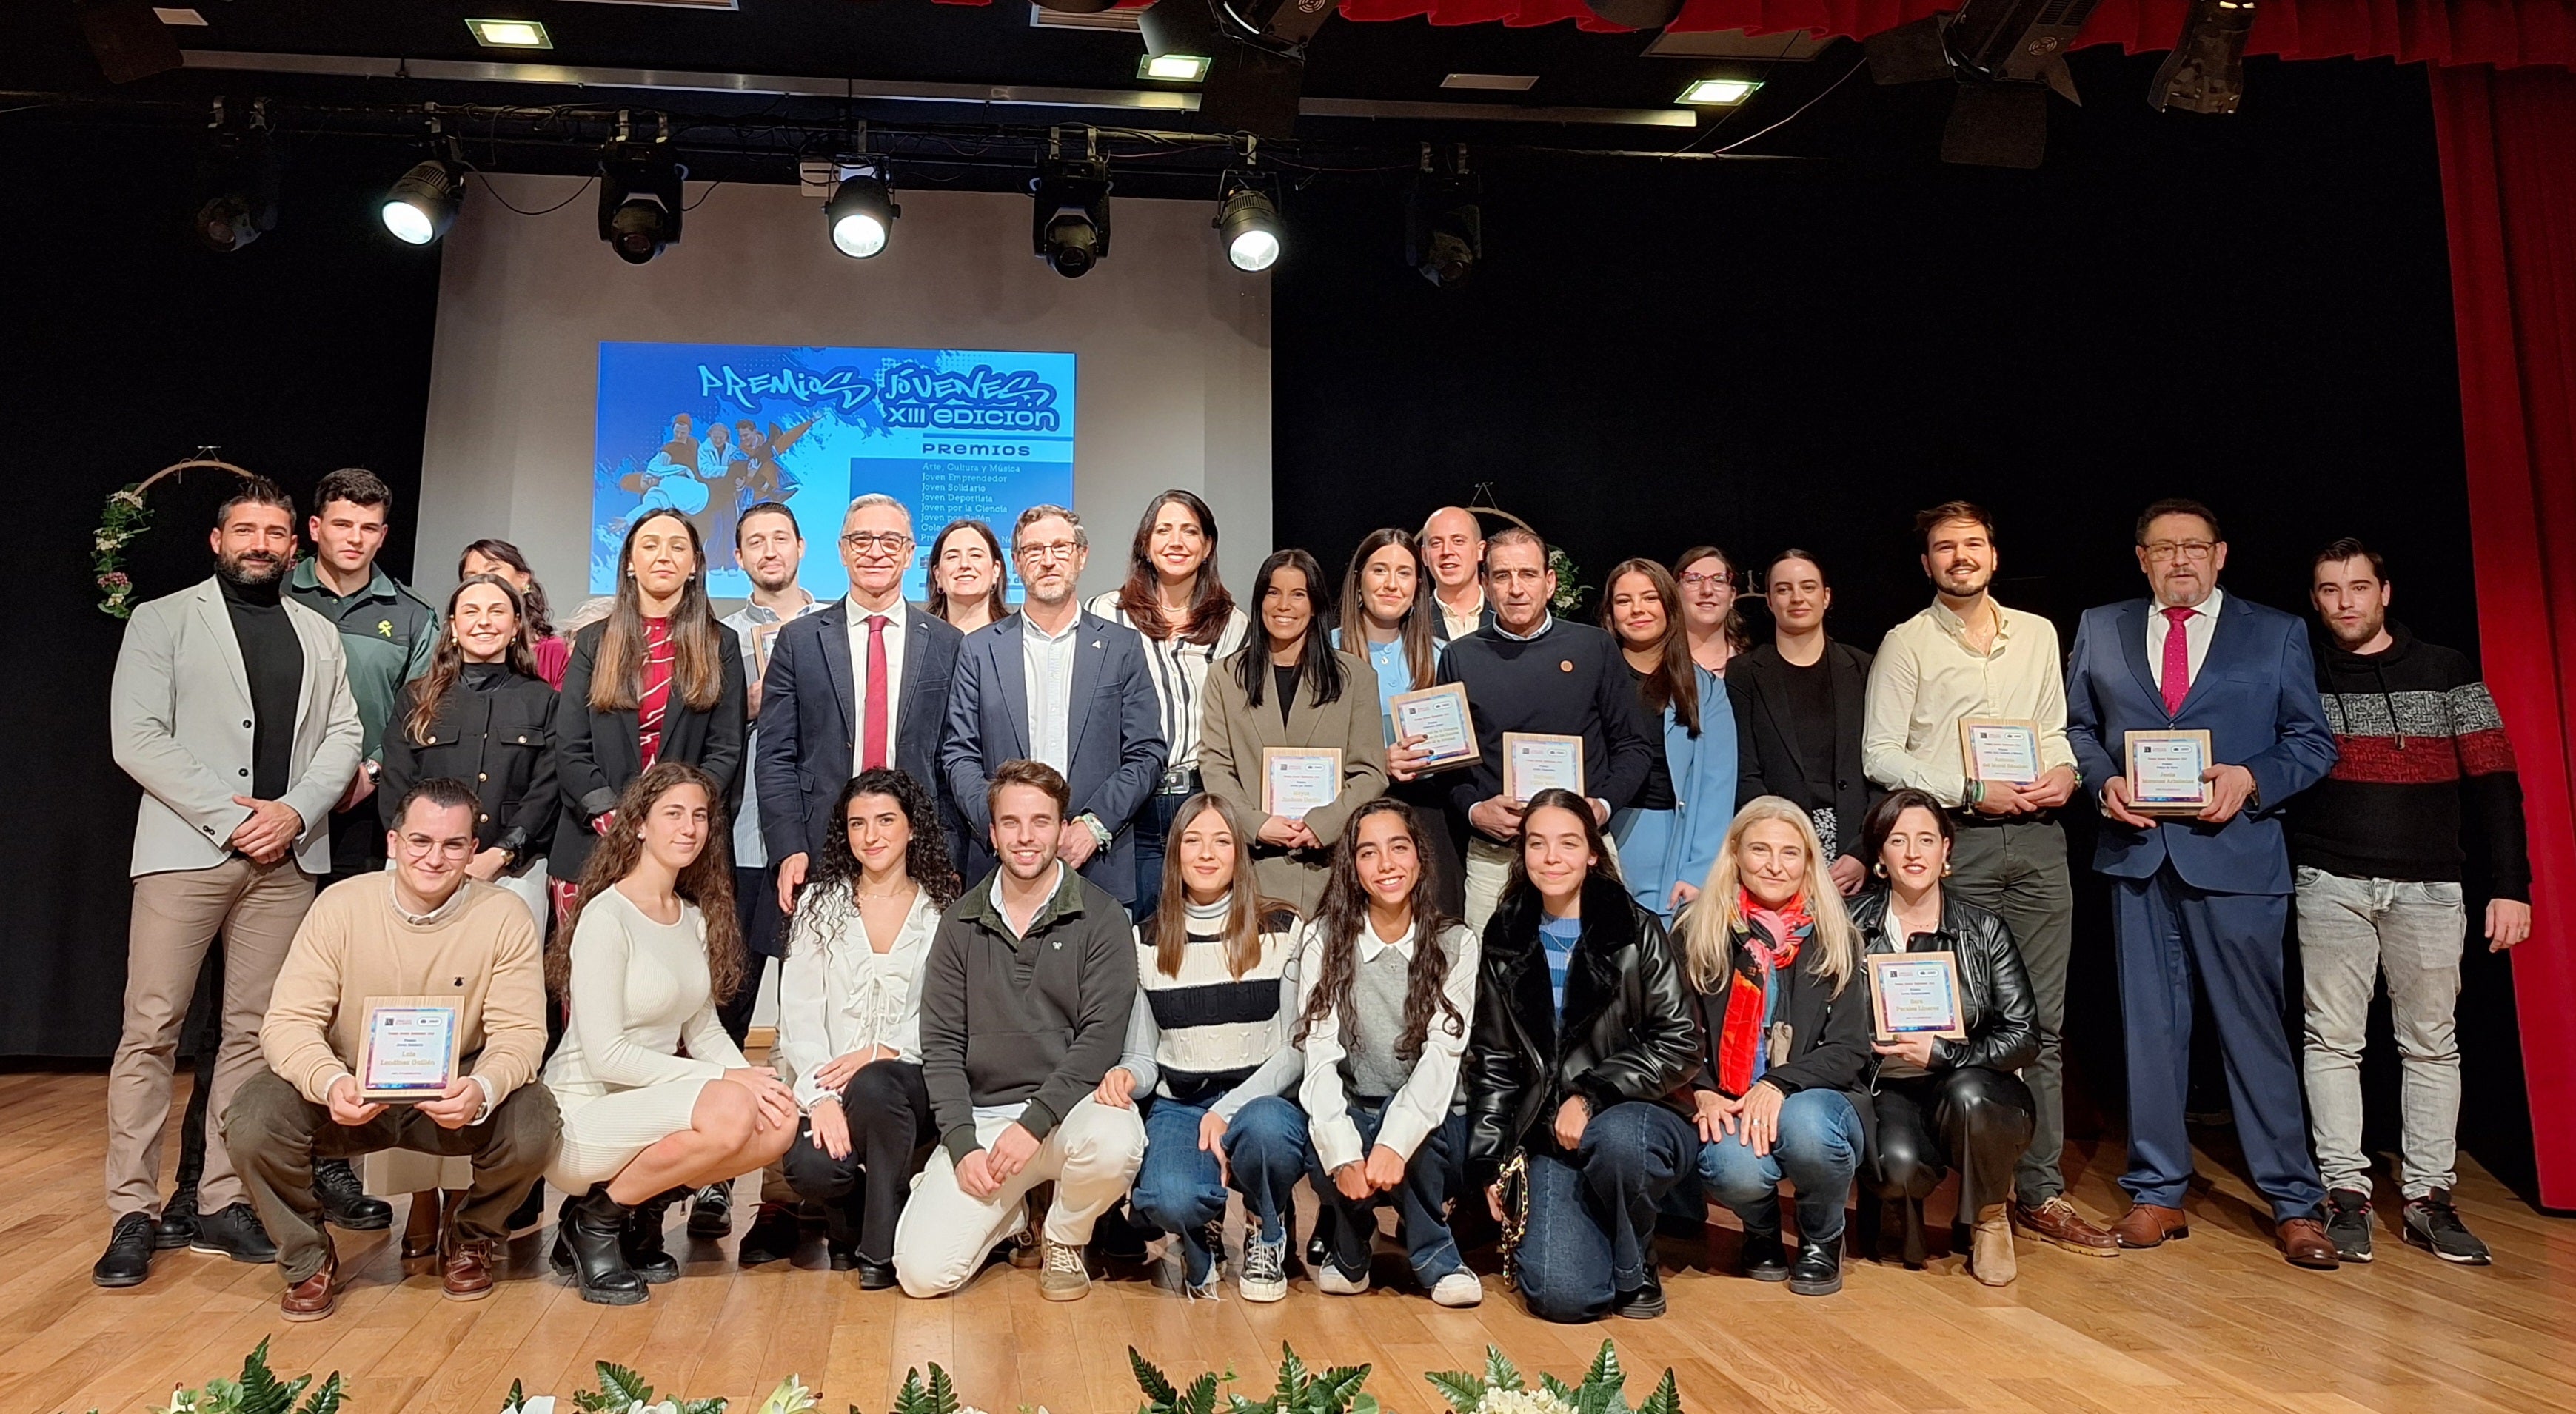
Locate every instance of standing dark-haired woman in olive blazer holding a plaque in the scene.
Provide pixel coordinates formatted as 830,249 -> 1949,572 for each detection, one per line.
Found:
1190,549 -> 1386,917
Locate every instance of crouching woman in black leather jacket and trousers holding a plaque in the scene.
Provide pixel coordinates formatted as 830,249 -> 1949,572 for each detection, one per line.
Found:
1852,788 -> 2040,1285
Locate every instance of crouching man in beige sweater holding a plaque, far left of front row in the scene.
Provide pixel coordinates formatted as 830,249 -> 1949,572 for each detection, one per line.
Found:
224,778 -> 559,1321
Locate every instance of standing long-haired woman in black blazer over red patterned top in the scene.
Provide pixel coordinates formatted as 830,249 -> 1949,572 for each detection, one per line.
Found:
546,510 -> 744,894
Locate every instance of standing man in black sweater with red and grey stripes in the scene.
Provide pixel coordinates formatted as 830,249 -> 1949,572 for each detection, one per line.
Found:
2290,538 -> 2532,1264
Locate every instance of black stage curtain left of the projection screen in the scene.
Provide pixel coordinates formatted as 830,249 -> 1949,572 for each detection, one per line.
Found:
0,118 -> 438,1056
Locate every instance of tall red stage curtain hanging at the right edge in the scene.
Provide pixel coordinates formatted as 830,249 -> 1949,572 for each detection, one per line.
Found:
2432,67 -> 2576,1208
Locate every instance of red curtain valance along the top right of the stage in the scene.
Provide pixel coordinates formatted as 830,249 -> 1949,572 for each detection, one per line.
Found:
1342,0 -> 2576,67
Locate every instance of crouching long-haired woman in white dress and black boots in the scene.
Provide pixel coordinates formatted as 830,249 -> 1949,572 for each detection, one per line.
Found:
546,763 -> 796,1306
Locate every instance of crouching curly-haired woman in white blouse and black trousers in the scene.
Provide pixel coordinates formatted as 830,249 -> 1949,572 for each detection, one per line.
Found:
778,768 -> 958,1290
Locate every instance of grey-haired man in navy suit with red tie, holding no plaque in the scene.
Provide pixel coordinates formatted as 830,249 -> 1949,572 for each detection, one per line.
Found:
752,495 -> 984,896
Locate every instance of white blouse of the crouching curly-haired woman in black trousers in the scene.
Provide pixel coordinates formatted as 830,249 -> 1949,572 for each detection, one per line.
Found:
778,883 -> 940,1108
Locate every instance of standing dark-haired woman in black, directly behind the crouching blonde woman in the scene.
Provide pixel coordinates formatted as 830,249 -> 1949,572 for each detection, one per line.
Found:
1726,549 -> 1873,897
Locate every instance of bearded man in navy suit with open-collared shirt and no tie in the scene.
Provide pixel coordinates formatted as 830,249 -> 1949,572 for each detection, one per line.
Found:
940,505 -> 1167,912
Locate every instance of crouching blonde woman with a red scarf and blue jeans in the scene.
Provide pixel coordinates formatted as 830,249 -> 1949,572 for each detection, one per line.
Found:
1677,796 -> 1876,1296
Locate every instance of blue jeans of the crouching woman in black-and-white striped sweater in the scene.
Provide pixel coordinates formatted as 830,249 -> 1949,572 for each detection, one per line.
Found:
1128,1095 -> 1306,1285
